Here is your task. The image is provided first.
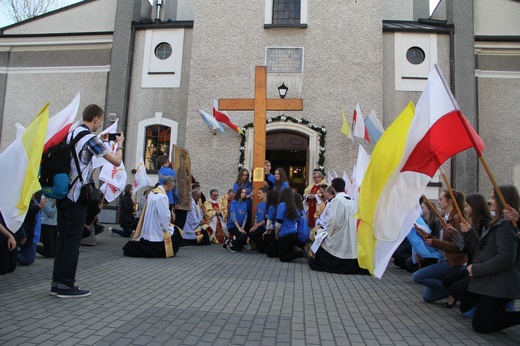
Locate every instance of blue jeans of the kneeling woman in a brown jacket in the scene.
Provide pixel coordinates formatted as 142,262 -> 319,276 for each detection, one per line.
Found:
412,260 -> 464,303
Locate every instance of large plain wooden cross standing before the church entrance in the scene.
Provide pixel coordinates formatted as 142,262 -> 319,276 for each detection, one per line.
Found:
218,66 -> 303,214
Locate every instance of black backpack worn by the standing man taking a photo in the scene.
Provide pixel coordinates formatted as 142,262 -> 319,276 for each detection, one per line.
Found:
40,131 -> 90,199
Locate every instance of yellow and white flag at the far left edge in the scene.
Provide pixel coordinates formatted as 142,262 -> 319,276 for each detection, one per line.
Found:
0,103 -> 49,232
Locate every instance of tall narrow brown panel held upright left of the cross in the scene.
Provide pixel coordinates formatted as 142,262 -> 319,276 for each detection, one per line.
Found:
172,145 -> 191,210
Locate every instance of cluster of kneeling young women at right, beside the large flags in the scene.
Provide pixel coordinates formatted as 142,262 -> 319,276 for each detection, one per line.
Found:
394,185 -> 520,333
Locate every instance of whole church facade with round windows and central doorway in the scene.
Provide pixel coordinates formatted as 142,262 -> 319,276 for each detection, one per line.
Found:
0,0 -> 520,220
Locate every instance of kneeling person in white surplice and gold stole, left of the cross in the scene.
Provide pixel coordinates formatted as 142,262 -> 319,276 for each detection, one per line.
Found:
123,177 -> 182,258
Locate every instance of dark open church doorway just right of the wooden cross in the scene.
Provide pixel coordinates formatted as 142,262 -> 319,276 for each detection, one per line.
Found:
265,130 -> 309,194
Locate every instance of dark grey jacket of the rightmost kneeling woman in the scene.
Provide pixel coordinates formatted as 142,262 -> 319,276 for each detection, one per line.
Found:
464,219 -> 520,299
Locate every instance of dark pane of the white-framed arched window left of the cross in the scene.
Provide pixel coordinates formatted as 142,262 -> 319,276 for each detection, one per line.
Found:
143,125 -> 171,173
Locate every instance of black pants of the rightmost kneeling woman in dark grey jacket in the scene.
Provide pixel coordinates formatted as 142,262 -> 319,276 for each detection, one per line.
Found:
472,295 -> 520,333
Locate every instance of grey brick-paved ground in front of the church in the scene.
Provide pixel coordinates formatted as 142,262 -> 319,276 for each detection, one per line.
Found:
0,224 -> 520,345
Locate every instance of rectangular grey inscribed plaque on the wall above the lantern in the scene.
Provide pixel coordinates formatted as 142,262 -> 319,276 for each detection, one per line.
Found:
265,48 -> 303,73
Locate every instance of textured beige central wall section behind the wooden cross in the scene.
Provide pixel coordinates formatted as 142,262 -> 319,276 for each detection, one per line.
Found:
186,0 -> 383,195
